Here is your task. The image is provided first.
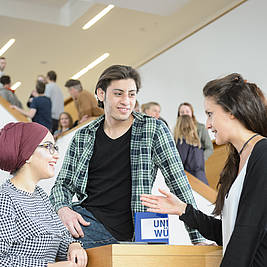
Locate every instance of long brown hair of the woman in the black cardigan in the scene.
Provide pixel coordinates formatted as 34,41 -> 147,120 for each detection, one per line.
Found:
203,73 -> 267,215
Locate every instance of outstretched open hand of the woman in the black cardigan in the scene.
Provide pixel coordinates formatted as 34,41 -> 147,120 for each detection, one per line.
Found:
140,189 -> 187,216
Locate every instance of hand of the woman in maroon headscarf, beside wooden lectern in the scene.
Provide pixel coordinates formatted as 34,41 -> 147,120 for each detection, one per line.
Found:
68,242 -> 87,267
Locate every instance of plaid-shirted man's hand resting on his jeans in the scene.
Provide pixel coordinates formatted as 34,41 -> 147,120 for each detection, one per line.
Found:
58,207 -> 90,238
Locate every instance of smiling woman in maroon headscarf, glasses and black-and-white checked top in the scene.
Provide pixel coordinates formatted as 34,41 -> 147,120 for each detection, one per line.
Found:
0,122 -> 87,267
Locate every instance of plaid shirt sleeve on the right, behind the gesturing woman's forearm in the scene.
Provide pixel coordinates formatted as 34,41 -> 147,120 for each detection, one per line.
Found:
153,121 -> 205,243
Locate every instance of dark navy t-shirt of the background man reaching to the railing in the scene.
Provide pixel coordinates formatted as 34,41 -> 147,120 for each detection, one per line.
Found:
30,96 -> 52,130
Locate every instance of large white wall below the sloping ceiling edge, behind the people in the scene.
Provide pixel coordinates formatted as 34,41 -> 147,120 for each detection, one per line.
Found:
138,0 -> 267,128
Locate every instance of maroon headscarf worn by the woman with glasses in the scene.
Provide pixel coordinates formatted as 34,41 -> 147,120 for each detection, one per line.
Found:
0,122 -> 48,173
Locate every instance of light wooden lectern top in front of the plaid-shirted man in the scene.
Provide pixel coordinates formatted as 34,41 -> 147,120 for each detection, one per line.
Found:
86,244 -> 222,267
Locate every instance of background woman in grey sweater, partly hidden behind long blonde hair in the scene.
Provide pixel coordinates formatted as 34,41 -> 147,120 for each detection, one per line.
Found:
177,102 -> 213,160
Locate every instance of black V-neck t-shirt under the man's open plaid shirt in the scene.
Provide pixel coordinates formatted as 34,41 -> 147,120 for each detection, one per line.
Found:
82,122 -> 133,241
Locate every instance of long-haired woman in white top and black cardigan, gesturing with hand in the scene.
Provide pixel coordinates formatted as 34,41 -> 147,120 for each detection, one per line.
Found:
141,73 -> 267,267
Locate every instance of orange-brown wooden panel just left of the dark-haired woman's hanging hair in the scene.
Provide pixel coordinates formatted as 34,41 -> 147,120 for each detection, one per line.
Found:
205,143 -> 228,190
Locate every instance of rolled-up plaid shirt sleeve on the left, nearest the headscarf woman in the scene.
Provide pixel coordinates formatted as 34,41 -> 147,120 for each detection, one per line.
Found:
50,135 -> 79,211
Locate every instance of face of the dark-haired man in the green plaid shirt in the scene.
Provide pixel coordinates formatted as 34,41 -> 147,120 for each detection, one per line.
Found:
97,79 -> 137,122
